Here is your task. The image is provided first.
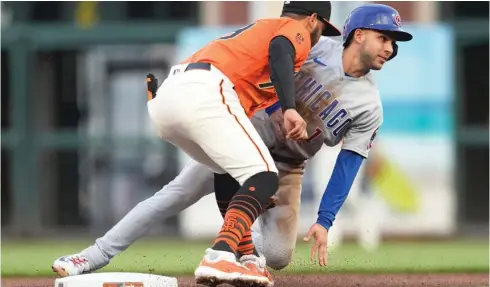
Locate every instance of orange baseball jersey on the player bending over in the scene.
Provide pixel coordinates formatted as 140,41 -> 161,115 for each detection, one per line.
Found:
182,17 -> 311,117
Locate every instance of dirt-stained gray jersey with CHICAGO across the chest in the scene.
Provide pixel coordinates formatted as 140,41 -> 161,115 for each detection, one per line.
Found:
252,37 -> 383,163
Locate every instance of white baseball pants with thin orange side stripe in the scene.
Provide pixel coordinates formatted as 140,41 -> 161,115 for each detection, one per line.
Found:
148,64 -> 277,185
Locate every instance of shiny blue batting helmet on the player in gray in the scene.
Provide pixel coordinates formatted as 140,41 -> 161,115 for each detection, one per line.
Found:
343,4 -> 413,60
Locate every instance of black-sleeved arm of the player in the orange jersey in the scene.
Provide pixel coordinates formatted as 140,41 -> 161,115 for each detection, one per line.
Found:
269,36 -> 296,111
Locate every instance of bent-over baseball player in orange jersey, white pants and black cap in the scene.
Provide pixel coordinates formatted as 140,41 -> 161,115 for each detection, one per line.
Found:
148,1 -> 340,285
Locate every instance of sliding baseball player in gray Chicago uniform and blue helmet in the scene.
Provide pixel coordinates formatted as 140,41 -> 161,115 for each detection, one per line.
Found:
53,4 -> 412,284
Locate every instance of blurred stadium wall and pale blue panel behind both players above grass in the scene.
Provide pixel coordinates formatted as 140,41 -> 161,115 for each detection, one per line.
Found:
1,1 -> 489,274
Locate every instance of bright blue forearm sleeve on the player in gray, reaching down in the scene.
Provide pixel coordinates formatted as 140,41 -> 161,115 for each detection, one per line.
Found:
316,149 -> 364,230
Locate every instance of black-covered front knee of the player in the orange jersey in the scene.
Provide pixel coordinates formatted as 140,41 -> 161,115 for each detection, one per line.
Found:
243,171 -> 279,207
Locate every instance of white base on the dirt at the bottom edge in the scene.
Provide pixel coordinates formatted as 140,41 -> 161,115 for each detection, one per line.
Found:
54,272 -> 177,287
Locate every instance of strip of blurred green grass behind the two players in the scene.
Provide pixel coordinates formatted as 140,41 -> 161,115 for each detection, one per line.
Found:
2,239 -> 489,276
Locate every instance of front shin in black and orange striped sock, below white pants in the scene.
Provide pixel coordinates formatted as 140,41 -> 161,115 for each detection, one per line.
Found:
213,172 -> 279,254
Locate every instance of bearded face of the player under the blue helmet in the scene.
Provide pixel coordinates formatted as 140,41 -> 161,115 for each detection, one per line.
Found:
361,30 -> 394,70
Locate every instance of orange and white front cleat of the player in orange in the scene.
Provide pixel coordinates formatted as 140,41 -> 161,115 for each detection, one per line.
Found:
194,248 -> 270,286
